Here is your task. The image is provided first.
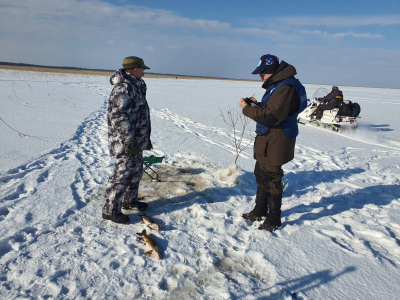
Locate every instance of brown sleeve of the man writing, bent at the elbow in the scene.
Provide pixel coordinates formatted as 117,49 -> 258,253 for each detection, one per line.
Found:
243,85 -> 296,127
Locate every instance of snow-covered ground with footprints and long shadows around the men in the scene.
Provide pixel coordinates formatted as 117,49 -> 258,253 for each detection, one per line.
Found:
0,70 -> 400,299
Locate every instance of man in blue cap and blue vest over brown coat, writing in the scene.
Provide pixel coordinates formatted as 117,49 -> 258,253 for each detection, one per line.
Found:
239,54 -> 307,231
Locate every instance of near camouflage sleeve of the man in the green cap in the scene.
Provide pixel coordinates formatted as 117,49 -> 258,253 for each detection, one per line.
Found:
108,84 -> 135,143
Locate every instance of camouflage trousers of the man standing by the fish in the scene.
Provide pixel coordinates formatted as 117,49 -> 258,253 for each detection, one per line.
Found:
103,153 -> 143,215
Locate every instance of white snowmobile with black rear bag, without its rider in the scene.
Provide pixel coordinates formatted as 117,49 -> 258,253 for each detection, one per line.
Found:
297,88 -> 361,132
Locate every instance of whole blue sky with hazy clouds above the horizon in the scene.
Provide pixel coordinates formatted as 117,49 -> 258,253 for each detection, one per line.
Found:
0,0 -> 400,88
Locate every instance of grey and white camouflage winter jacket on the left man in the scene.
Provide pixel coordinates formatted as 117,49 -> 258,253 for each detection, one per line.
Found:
107,69 -> 153,157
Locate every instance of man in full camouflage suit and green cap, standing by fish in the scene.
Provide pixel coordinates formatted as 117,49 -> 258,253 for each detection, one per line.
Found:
103,56 -> 153,223
